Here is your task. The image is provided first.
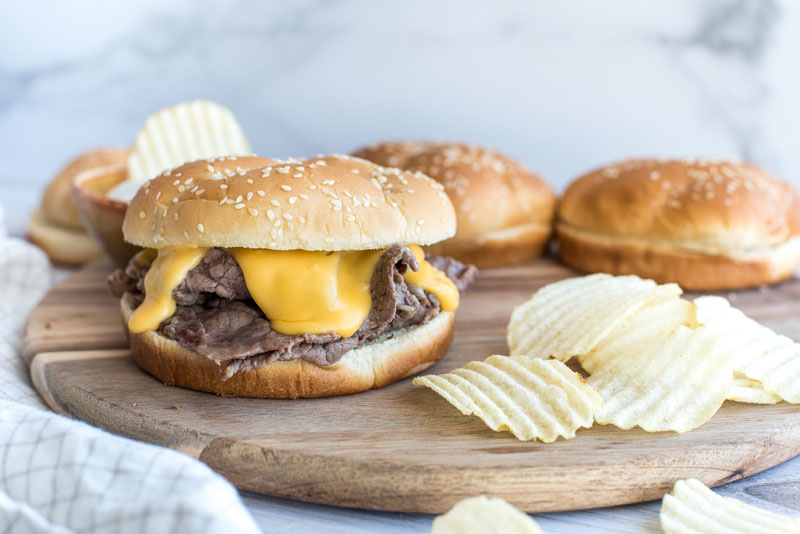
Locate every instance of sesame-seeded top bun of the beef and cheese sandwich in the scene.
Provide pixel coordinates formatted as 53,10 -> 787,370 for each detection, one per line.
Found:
123,155 -> 456,251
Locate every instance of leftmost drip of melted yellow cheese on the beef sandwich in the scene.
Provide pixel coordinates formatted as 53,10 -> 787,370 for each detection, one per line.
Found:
128,247 -> 208,334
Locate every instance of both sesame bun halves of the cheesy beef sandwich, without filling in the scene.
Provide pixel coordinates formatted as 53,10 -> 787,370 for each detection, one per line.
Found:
121,156 -> 455,398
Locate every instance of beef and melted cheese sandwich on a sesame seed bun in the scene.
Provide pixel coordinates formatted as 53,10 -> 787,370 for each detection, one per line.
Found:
109,156 -> 475,398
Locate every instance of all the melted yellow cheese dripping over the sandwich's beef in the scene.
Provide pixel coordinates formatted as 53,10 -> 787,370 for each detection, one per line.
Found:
128,245 -> 458,337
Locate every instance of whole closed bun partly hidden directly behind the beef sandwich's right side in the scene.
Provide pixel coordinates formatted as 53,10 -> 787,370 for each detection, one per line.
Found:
354,142 -> 556,268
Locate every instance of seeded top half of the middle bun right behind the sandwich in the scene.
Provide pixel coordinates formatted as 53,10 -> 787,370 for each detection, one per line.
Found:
354,142 -> 555,239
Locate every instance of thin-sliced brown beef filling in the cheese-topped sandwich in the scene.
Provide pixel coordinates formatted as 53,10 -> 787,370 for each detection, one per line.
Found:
109,245 -> 475,378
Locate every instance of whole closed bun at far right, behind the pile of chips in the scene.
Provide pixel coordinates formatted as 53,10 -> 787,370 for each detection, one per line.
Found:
556,159 -> 800,290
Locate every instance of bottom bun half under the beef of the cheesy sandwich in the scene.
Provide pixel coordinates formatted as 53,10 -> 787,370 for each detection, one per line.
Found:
120,293 -> 455,399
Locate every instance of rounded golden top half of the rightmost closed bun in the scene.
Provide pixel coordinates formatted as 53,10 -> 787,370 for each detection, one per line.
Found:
558,159 -> 800,255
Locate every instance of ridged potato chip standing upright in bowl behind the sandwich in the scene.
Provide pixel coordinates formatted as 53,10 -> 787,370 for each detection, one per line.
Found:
128,100 -> 251,182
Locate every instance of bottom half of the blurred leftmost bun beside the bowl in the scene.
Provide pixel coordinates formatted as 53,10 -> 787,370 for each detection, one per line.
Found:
28,208 -> 103,265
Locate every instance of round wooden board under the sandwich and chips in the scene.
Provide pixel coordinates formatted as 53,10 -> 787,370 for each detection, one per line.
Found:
25,260 -> 800,513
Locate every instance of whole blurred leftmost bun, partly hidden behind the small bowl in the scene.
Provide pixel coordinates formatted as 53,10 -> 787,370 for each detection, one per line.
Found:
28,148 -> 128,265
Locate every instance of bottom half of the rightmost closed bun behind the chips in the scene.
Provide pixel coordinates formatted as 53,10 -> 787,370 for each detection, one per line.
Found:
556,224 -> 800,291
